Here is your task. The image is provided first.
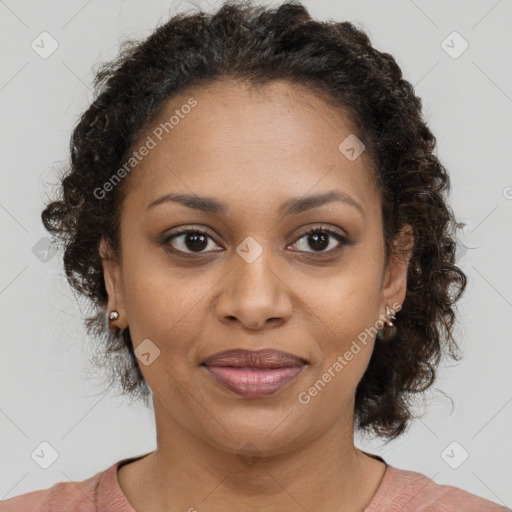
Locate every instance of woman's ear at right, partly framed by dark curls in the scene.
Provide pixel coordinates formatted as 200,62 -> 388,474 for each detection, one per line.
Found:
382,224 -> 414,314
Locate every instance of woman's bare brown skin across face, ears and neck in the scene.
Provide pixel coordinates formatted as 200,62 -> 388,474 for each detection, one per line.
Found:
100,79 -> 412,512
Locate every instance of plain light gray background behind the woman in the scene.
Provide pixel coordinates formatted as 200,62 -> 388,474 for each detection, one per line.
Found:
0,0 -> 512,507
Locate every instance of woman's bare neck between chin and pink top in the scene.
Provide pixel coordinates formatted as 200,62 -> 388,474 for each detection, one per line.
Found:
119,400 -> 385,512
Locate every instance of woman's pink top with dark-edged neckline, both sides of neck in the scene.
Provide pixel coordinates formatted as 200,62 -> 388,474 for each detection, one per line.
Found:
0,455 -> 509,512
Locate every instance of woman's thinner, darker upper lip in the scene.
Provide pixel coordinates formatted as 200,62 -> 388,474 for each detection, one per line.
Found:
202,349 -> 307,368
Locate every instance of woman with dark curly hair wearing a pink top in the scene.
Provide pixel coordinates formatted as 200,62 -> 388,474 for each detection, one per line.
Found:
0,2 -> 505,512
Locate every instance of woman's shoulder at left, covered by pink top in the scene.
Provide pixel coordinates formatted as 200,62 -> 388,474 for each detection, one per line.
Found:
0,463 -> 118,512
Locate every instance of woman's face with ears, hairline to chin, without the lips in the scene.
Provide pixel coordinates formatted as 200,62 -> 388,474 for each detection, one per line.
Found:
101,81 -> 412,453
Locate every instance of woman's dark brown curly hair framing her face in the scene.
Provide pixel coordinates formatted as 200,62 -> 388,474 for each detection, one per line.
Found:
42,0 -> 466,441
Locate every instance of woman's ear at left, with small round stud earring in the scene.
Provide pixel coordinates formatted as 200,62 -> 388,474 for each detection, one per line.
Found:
99,238 -> 128,329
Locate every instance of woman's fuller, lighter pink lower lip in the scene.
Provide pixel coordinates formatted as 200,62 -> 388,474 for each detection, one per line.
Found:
200,365 -> 305,398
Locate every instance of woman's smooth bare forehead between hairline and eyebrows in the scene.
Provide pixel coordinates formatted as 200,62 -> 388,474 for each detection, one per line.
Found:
124,79 -> 377,216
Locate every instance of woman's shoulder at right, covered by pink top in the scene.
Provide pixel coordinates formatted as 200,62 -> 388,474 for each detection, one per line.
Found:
366,464 -> 509,512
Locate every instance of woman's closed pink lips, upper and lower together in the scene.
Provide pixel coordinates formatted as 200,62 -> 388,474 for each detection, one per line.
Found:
201,349 -> 307,398
